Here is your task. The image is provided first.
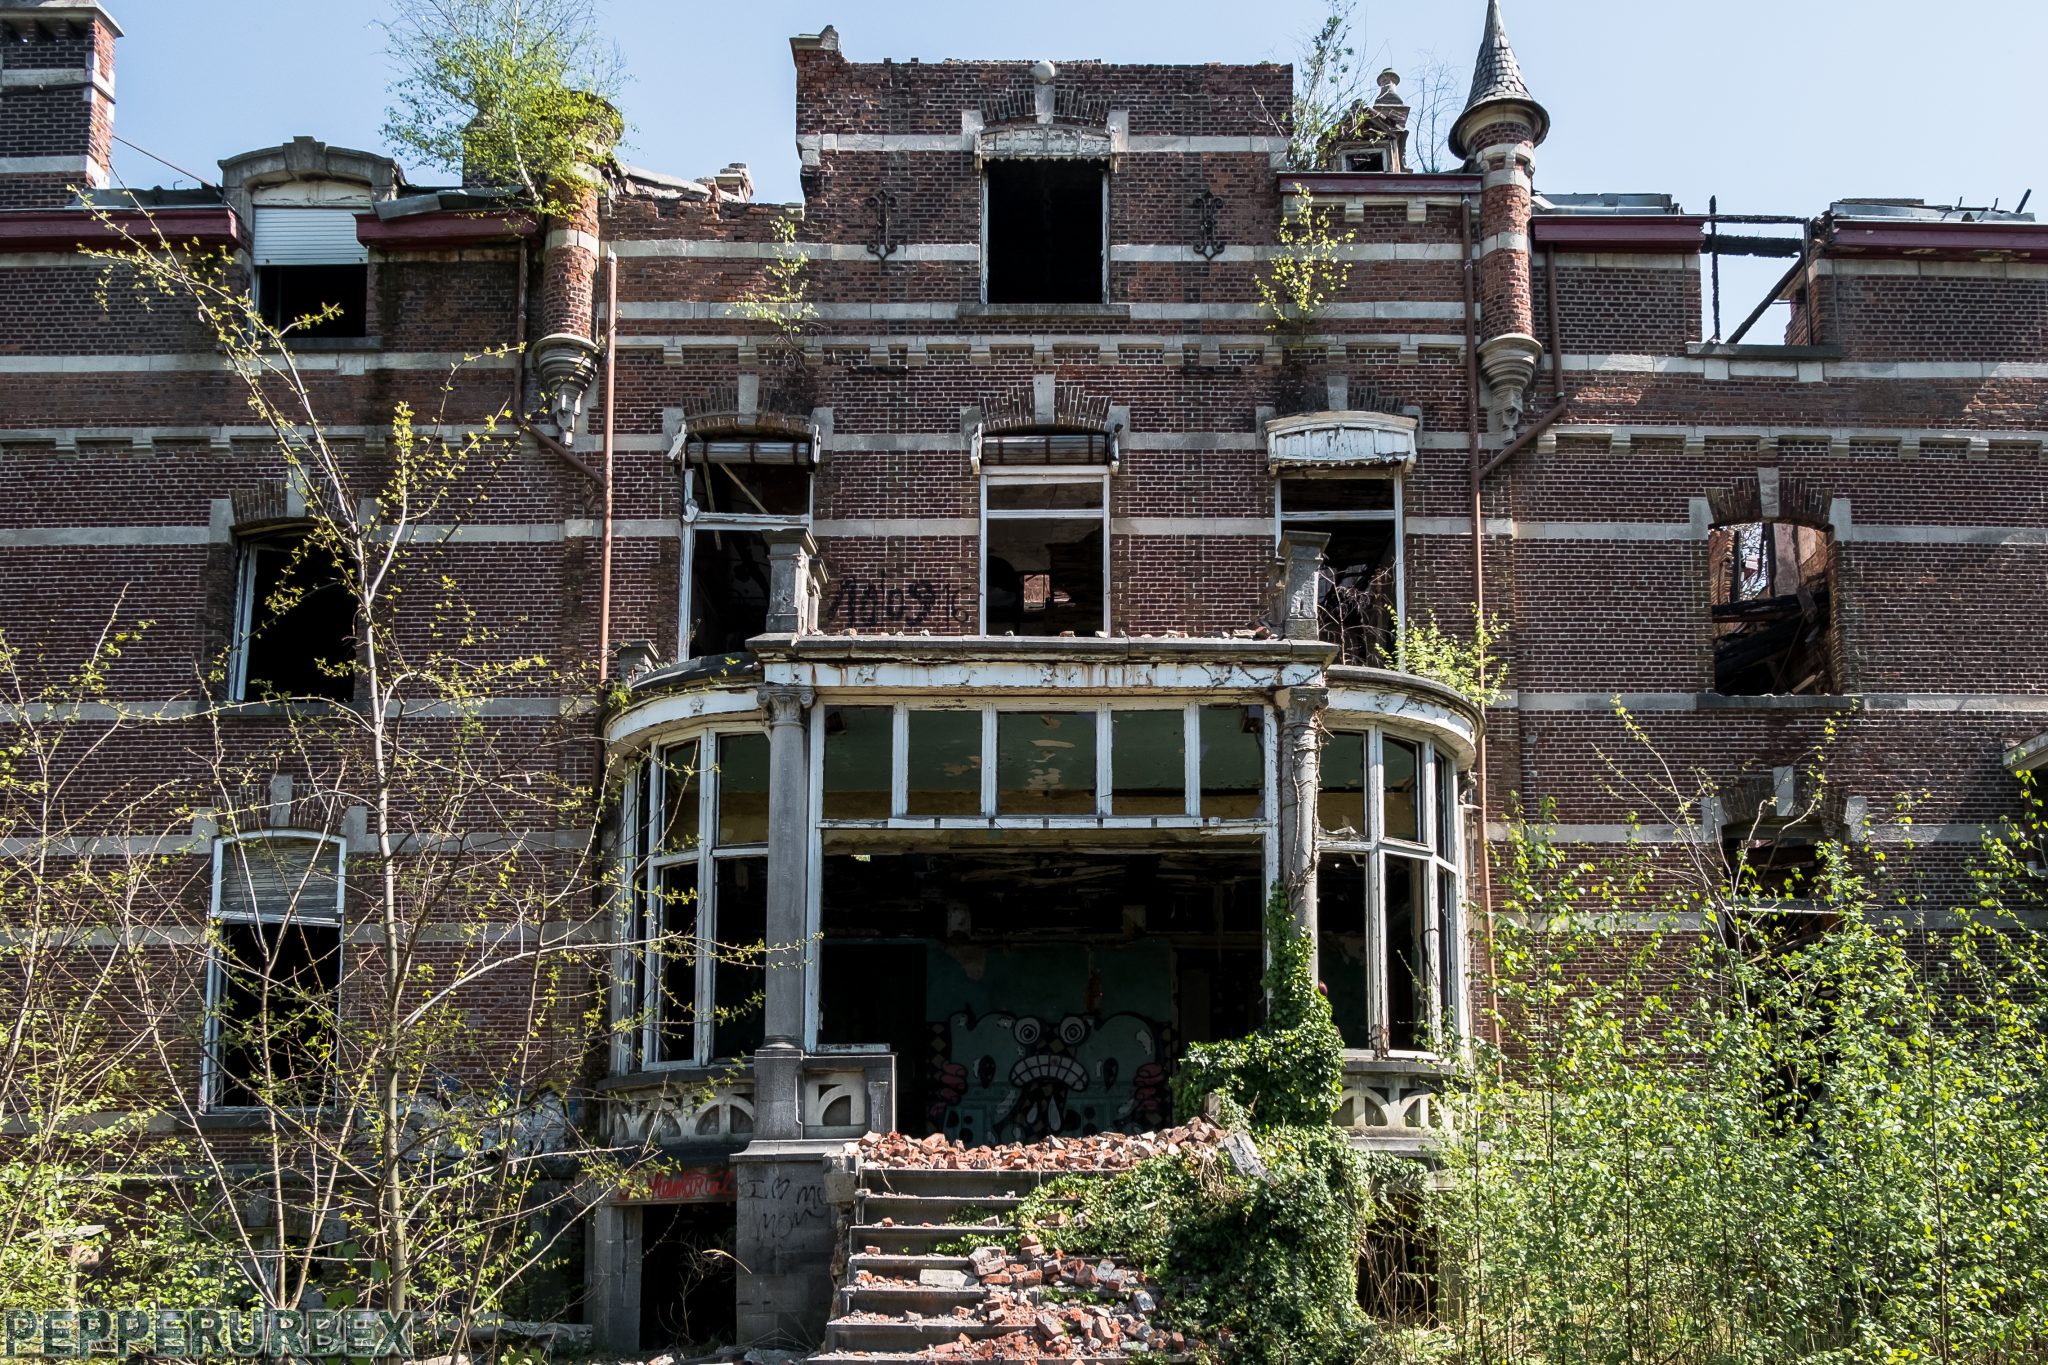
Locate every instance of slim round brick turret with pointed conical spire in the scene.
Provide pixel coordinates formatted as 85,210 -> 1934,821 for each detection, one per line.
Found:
1450,0 -> 1550,432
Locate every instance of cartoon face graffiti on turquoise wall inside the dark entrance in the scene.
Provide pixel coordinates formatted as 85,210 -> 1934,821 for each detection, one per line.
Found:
930,1009 -> 1174,1144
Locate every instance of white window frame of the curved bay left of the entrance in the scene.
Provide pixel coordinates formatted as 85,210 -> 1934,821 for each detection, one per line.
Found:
633,722 -> 774,1070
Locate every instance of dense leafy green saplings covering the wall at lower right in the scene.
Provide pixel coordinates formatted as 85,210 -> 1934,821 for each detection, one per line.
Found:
1430,763 -> 2048,1365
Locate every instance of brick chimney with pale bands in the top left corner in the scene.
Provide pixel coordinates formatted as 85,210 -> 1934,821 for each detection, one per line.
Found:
0,0 -> 121,209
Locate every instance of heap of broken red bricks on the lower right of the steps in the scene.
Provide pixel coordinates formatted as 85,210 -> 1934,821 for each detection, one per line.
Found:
854,1232 -> 1188,1361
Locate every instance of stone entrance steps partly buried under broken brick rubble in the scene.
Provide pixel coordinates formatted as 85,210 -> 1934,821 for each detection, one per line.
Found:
811,1164 -> 1180,1365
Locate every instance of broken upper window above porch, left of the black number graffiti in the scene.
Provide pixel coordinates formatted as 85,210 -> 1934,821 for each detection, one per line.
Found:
680,432 -> 815,659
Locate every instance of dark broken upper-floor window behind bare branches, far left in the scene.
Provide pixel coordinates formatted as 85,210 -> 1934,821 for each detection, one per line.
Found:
233,526 -> 356,702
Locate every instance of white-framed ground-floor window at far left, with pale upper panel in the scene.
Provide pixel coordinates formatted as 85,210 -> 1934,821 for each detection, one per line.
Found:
205,835 -> 342,1109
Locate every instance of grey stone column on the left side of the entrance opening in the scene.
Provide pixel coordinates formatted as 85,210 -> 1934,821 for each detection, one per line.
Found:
754,686 -> 815,1140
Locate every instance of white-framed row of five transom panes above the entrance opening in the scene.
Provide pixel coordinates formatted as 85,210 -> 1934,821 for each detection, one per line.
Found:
811,696 -> 1278,833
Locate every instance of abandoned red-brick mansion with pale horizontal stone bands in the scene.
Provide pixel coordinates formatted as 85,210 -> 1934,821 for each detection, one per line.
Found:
0,0 -> 2048,1347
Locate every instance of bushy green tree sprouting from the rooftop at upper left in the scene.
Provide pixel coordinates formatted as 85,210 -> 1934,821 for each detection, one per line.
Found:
383,0 -> 623,217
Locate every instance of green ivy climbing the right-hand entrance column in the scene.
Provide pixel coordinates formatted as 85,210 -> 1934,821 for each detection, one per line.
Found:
1174,886 -> 1343,1128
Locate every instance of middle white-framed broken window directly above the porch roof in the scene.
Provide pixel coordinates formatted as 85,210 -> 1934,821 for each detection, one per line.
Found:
981,473 -> 1110,634
